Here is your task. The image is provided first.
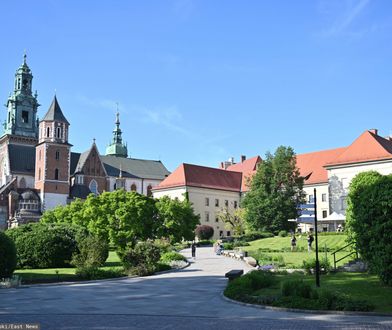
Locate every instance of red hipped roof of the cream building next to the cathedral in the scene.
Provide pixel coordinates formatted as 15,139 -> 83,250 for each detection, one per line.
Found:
154,164 -> 242,192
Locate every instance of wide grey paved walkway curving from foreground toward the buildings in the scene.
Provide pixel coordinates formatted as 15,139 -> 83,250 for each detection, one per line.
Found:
0,248 -> 392,329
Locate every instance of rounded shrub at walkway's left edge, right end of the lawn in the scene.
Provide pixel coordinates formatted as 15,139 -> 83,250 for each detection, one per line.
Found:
122,241 -> 161,276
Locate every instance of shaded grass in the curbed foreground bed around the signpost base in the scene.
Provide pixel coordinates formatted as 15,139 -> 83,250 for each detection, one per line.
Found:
226,273 -> 392,313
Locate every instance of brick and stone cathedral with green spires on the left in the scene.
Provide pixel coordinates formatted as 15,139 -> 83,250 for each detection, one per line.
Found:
0,55 -> 169,229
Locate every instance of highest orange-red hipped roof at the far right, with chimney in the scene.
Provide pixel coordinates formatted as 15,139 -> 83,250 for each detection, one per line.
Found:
326,131 -> 392,167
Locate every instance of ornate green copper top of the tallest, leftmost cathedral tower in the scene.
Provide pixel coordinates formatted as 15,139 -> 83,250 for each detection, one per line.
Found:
3,54 -> 39,138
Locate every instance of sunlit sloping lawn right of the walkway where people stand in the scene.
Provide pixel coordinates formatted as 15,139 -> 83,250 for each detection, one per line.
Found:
241,234 -> 355,268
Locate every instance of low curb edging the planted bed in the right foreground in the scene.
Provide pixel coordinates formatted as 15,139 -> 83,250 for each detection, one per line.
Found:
220,292 -> 392,318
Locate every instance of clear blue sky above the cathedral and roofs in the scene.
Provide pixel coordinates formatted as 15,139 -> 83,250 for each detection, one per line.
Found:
0,0 -> 392,170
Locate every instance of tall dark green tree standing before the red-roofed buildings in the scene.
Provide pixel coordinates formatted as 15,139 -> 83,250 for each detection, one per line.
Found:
242,146 -> 305,232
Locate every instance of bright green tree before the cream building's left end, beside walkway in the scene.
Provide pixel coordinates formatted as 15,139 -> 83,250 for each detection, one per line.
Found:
155,196 -> 200,243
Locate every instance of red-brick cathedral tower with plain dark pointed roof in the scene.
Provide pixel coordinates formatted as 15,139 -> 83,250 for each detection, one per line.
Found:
35,96 -> 71,209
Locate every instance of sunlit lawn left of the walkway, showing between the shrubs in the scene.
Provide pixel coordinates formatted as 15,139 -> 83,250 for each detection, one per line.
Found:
14,251 -> 122,283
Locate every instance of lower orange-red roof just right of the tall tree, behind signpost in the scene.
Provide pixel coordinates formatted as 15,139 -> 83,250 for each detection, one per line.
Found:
297,148 -> 346,184
